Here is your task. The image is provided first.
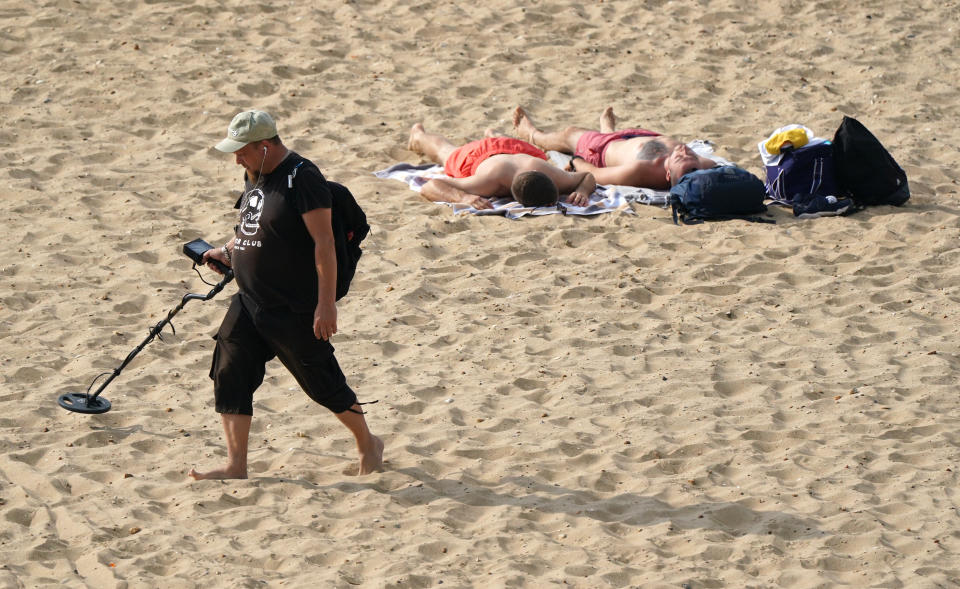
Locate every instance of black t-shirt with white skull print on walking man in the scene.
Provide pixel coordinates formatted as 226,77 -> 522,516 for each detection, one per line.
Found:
233,151 -> 331,313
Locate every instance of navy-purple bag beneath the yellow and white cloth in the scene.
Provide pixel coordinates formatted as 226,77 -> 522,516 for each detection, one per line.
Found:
764,141 -> 839,205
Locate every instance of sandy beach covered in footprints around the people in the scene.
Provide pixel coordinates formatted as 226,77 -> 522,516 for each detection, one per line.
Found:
0,0 -> 960,589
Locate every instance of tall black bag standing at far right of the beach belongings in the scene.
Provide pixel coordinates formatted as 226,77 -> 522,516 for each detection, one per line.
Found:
833,116 -> 910,207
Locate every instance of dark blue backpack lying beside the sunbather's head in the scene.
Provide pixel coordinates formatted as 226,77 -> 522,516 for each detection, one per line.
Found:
670,166 -> 776,225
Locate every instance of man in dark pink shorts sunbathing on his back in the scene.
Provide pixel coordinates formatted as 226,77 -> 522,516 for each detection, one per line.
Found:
513,106 -> 717,190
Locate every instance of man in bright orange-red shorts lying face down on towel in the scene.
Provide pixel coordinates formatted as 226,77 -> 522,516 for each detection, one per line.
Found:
407,123 -> 597,209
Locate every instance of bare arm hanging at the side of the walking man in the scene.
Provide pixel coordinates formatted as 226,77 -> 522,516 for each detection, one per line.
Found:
303,209 -> 337,340
